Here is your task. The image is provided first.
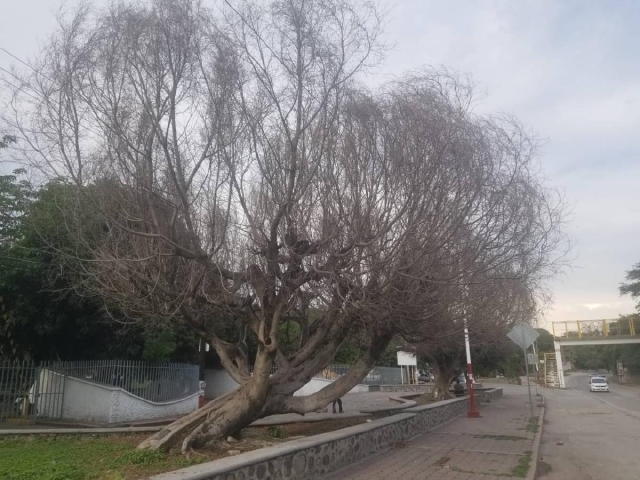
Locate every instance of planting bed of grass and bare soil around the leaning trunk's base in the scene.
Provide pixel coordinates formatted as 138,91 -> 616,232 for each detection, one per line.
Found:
0,416 -> 366,480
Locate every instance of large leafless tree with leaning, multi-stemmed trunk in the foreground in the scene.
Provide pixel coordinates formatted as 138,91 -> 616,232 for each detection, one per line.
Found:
4,0 -> 565,452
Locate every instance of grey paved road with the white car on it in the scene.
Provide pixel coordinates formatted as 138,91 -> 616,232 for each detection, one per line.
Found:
537,374 -> 640,480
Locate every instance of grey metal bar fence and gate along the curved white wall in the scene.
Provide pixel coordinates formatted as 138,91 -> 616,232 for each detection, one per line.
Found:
0,359 -> 200,423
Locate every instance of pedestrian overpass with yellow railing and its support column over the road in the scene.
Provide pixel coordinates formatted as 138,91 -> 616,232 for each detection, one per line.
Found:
551,317 -> 640,388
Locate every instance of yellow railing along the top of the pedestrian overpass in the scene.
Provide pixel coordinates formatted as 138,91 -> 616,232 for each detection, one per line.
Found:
551,317 -> 640,340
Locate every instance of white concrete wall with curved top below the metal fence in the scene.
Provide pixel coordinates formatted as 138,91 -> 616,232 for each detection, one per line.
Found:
62,377 -> 199,423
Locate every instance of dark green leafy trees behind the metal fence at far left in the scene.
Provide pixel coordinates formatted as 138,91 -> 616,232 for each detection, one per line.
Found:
0,178 -> 197,361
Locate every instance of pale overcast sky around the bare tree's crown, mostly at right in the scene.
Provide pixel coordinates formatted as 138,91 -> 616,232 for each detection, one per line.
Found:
0,0 -> 640,328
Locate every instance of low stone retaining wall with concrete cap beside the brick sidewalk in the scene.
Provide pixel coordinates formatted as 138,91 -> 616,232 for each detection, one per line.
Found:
151,389 -> 502,480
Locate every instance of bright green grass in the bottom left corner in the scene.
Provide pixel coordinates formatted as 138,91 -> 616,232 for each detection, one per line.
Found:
0,437 -> 207,480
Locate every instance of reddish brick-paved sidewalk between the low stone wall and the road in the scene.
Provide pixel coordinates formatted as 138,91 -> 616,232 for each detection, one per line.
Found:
325,394 -> 538,480
